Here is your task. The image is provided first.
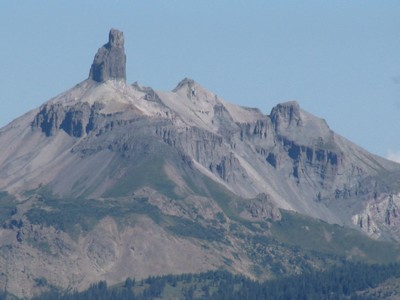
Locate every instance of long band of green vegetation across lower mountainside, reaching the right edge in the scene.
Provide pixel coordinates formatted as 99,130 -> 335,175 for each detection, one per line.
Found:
19,168 -> 399,288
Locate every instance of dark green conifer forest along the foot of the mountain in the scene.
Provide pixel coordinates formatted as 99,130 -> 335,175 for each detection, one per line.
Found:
29,262 -> 400,300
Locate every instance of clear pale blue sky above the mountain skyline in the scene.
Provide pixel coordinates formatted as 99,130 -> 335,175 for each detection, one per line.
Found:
0,0 -> 400,161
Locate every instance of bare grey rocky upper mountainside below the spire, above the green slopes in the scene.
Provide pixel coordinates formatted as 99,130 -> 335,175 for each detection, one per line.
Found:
0,76 -> 399,223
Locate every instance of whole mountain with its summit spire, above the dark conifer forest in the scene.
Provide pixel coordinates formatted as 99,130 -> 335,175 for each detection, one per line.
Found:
0,29 -> 400,296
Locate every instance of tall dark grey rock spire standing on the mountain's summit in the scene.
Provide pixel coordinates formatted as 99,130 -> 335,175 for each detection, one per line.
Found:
89,29 -> 126,82
